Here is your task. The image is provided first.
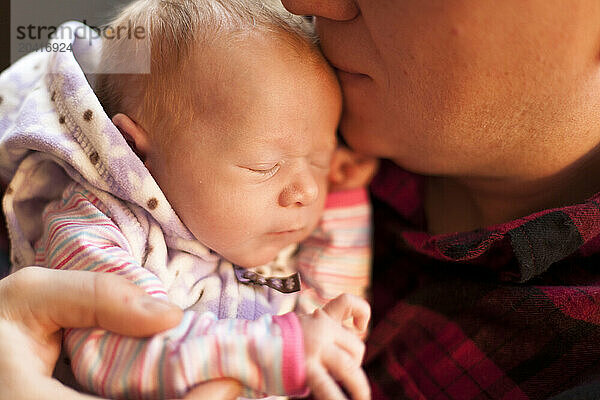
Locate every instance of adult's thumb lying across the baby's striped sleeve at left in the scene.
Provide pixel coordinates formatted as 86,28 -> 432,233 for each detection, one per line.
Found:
0,267 -> 183,336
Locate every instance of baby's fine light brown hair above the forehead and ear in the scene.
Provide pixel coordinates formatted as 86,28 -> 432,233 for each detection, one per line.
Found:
93,0 -> 320,143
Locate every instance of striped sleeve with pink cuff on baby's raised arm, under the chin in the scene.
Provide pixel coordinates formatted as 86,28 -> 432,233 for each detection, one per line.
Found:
297,188 -> 371,313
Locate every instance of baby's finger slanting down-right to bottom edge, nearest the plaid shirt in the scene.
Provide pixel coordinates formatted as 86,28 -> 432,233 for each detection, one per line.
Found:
323,349 -> 371,400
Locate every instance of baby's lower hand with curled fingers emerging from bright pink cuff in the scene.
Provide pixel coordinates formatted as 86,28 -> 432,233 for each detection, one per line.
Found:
298,294 -> 371,400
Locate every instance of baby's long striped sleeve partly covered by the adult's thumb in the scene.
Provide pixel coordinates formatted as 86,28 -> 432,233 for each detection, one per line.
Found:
36,185 -> 306,399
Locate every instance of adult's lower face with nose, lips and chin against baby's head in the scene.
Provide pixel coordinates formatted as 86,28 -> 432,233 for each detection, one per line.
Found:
283,0 -> 600,176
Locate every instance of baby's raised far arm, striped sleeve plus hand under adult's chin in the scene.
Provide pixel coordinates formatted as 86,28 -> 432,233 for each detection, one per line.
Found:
297,145 -> 378,312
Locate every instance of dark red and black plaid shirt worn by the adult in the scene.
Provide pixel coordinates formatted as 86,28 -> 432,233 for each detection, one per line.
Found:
365,163 -> 600,400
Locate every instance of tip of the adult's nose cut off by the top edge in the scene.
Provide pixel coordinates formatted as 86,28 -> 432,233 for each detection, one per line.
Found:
282,0 -> 360,21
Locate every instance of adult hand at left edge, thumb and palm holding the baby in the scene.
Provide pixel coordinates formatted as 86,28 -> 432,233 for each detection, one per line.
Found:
0,267 -> 183,400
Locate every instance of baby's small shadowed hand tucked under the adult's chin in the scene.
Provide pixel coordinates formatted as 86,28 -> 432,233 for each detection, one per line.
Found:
328,146 -> 378,192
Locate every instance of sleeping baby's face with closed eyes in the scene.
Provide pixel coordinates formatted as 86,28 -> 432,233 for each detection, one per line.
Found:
146,34 -> 341,267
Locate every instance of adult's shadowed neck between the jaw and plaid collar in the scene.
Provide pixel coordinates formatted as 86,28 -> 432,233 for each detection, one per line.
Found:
425,147 -> 600,234
